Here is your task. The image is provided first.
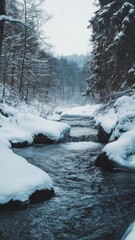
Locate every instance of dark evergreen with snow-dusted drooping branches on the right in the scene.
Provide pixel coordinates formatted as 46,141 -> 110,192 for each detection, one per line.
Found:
87,0 -> 135,100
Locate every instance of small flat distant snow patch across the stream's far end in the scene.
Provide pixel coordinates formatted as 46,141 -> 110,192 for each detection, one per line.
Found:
61,104 -> 101,119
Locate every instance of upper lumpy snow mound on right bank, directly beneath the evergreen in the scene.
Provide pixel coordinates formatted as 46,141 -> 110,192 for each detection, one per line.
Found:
95,95 -> 135,138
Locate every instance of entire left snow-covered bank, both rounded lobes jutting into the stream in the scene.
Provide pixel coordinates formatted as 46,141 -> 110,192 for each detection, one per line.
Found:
0,105 -> 70,209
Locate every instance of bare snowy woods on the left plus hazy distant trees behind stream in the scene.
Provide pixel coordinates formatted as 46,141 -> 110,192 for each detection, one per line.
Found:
0,0 -> 89,107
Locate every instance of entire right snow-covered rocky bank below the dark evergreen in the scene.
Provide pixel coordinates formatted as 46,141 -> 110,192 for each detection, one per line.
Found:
96,95 -> 135,170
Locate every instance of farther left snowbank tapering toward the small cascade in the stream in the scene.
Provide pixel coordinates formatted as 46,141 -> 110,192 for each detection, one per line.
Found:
0,109 -> 71,145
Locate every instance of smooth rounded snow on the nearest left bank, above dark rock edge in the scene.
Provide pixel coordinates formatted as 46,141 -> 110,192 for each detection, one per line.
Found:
0,142 -> 53,204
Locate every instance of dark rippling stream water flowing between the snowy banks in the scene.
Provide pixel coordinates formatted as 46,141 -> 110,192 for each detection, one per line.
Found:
0,120 -> 135,240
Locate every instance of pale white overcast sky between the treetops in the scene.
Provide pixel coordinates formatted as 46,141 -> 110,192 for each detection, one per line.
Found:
44,0 -> 96,55
